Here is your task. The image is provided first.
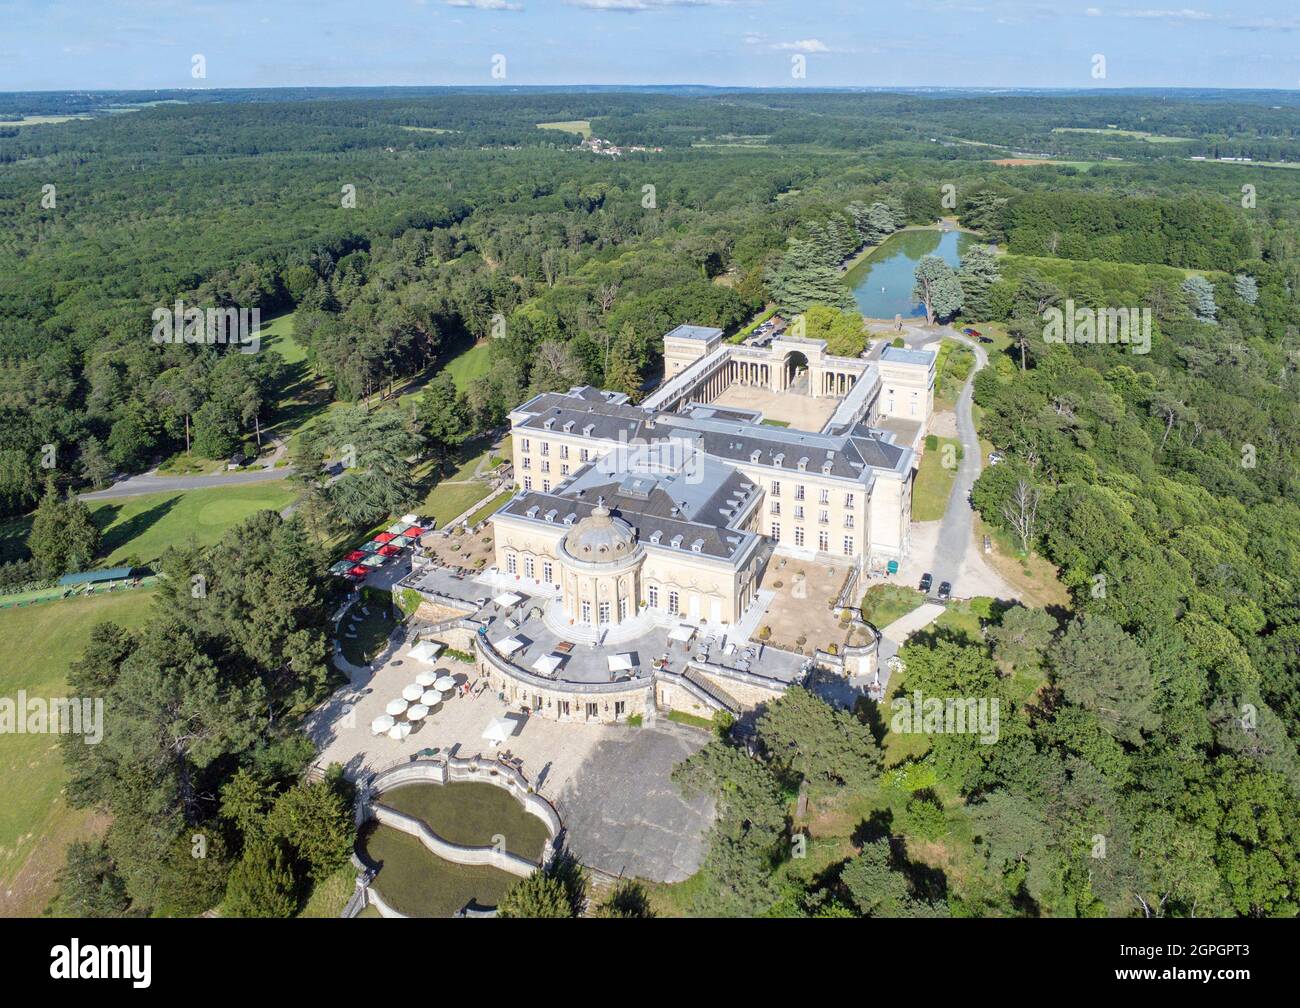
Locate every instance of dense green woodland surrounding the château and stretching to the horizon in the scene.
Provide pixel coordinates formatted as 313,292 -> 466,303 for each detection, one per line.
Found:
0,91 -> 1300,916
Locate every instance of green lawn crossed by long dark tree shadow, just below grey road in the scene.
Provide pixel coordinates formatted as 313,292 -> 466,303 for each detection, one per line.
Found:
91,480 -> 298,567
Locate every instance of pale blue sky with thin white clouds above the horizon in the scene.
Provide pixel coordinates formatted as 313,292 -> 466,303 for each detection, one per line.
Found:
0,0 -> 1300,91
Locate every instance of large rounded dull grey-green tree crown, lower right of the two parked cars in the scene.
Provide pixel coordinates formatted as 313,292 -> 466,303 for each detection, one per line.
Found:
1050,614 -> 1160,745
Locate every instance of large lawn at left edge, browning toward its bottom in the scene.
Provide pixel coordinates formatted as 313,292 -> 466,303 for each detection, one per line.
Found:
0,589 -> 153,917
